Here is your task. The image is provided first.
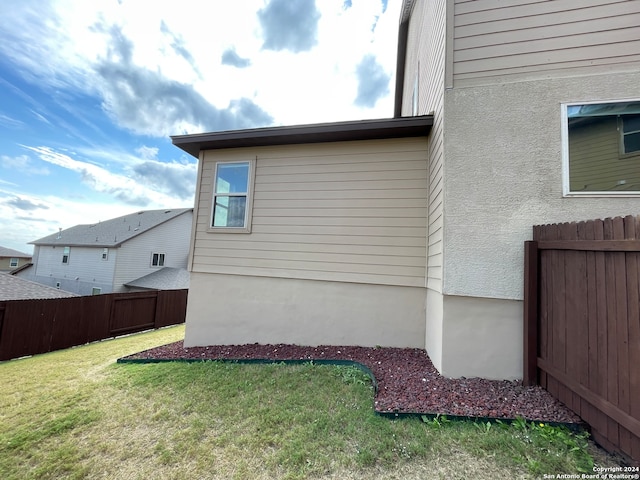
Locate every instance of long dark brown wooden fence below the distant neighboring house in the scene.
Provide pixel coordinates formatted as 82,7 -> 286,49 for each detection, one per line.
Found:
0,290 -> 187,360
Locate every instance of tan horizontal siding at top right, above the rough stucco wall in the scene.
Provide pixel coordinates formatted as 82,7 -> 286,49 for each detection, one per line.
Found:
453,0 -> 640,85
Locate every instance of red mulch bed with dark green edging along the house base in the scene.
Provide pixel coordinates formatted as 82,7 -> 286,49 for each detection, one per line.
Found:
119,341 -> 582,424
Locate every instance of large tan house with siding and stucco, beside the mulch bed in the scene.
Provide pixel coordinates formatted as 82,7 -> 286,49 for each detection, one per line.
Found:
173,0 -> 640,378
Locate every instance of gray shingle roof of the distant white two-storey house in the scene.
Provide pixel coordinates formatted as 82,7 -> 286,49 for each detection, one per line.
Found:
29,208 -> 193,247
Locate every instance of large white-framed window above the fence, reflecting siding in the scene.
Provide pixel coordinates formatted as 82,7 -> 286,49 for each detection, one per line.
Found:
562,100 -> 640,196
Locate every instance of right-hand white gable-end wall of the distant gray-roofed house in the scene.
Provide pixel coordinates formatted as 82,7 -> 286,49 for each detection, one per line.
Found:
113,211 -> 193,292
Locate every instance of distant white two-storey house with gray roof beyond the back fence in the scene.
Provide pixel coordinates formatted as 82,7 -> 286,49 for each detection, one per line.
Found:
18,208 -> 193,295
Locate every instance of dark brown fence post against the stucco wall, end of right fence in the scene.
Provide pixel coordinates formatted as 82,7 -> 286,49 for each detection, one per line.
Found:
522,241 -> 539,386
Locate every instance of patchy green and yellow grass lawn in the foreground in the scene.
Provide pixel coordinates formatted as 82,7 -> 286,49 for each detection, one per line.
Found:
0,326 -> 620,480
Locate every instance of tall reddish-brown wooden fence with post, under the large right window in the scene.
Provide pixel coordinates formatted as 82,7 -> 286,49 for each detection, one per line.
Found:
524,216 -> 640,462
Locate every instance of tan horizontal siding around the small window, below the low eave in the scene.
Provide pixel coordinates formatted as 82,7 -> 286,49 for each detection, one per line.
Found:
193,138 -> 427,286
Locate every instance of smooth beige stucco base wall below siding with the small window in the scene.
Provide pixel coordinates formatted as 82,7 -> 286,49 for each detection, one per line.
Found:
185,273 -> 425,348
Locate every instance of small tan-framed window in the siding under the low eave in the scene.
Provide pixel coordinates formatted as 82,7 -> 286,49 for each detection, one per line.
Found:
211,161 -> 255,232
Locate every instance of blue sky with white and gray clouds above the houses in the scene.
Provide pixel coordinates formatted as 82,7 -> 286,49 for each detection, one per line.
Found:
0,0 -> 401,253
